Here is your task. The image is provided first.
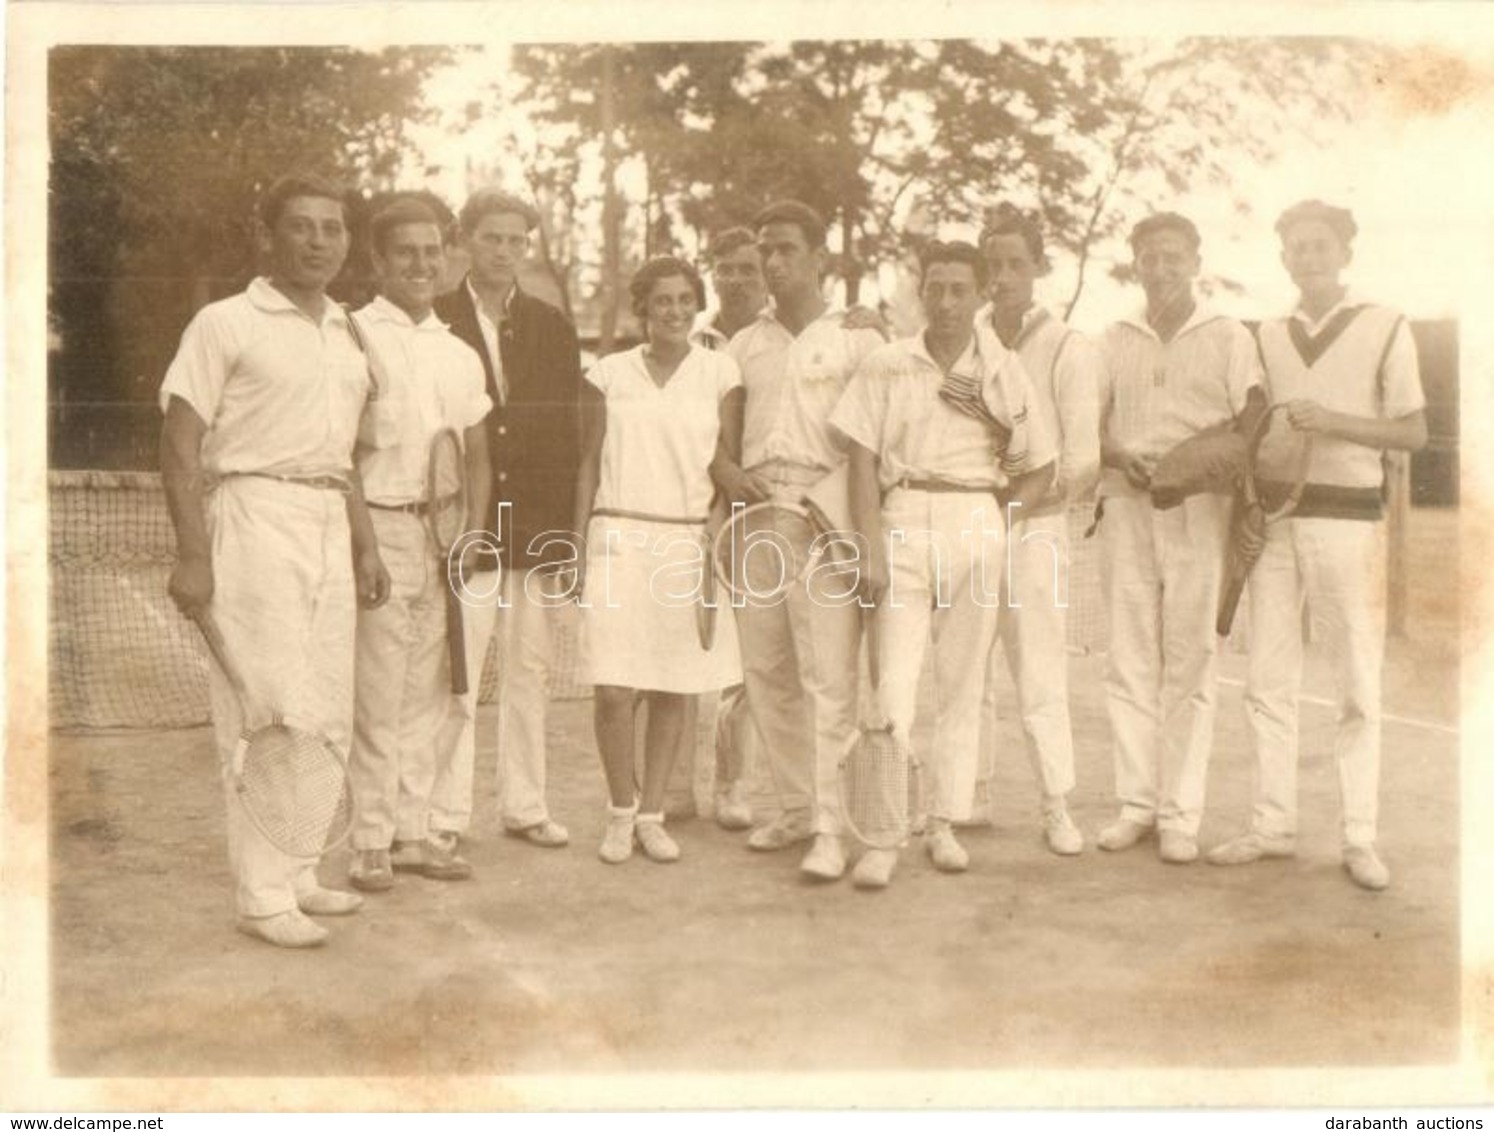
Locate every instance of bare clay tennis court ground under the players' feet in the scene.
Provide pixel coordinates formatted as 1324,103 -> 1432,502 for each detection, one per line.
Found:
51,512 -> 1461,1077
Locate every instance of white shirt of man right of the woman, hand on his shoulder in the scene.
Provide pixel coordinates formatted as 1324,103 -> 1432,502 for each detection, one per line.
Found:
726,308 -> 884,470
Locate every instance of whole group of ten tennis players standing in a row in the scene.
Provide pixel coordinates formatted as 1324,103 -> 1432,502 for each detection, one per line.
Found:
160,175 -> 1425,947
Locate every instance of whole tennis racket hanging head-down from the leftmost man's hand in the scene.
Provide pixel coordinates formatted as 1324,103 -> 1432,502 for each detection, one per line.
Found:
193,609 -> 353,857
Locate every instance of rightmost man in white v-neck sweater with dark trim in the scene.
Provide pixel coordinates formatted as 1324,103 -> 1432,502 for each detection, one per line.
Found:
1209,200 -> 1427,890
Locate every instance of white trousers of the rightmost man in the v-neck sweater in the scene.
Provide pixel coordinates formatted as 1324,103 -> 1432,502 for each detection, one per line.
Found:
1245,518 -> 1386,845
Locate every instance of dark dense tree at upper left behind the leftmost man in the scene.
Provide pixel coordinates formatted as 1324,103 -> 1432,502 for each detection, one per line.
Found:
48,46 -> 450,465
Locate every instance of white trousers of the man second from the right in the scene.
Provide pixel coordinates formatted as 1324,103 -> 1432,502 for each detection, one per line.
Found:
1100,494 -> 1230,836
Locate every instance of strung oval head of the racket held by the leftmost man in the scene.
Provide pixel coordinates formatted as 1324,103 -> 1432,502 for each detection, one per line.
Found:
238,727 -> 353,857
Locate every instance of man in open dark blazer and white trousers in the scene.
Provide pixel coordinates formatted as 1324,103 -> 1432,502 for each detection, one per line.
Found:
432,188 -> 581,848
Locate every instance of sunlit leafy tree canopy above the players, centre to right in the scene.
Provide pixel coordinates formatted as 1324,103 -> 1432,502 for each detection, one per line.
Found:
504,39 -> 1379,319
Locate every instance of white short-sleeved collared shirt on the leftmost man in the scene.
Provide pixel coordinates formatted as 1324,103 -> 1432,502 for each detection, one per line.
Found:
160,278 -> 372,475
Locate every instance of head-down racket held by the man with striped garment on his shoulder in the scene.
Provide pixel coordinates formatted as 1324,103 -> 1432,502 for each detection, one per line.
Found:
838,608 -> 923,850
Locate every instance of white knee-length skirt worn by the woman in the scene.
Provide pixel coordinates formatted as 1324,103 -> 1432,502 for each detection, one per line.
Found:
580,515 -> 741,694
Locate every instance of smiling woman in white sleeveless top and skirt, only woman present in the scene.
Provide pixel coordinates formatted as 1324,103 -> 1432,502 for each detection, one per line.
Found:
577,255 -> 743,865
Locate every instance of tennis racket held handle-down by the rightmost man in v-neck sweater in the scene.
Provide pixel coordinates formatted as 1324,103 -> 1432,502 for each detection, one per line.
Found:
1215,405 -> 1312,636
